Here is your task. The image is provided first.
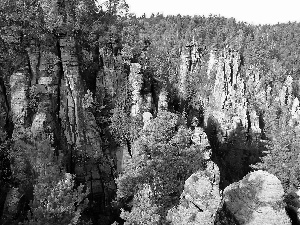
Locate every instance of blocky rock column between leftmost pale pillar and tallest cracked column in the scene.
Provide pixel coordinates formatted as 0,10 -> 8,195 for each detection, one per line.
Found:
28,43 -> 61,144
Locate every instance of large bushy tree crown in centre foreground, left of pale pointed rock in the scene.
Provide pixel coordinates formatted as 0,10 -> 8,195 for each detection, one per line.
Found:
117,111 -> 203,224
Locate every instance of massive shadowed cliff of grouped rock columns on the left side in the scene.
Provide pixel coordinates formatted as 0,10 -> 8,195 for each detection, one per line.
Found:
0,1 -> 116,223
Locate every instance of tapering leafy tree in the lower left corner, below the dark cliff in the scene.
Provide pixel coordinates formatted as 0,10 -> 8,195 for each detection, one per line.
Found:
24,138 -> 89,225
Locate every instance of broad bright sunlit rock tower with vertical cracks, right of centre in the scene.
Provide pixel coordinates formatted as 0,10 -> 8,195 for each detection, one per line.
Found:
205,48 -> 248,138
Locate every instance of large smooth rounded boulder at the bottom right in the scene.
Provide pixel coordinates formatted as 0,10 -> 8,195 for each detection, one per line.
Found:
223,170 -> 291,225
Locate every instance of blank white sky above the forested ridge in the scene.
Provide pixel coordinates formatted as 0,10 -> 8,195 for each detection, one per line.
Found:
126,0 -> 300,25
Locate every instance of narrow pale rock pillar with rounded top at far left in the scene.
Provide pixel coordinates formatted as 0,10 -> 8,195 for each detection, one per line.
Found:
0,67 -> 30,223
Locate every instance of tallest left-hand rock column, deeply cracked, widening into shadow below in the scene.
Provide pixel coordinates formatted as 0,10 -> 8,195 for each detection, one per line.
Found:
60,37 -> 104,195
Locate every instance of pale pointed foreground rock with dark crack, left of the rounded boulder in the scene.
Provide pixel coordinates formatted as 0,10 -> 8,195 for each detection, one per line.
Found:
167,161 -> 221,225
